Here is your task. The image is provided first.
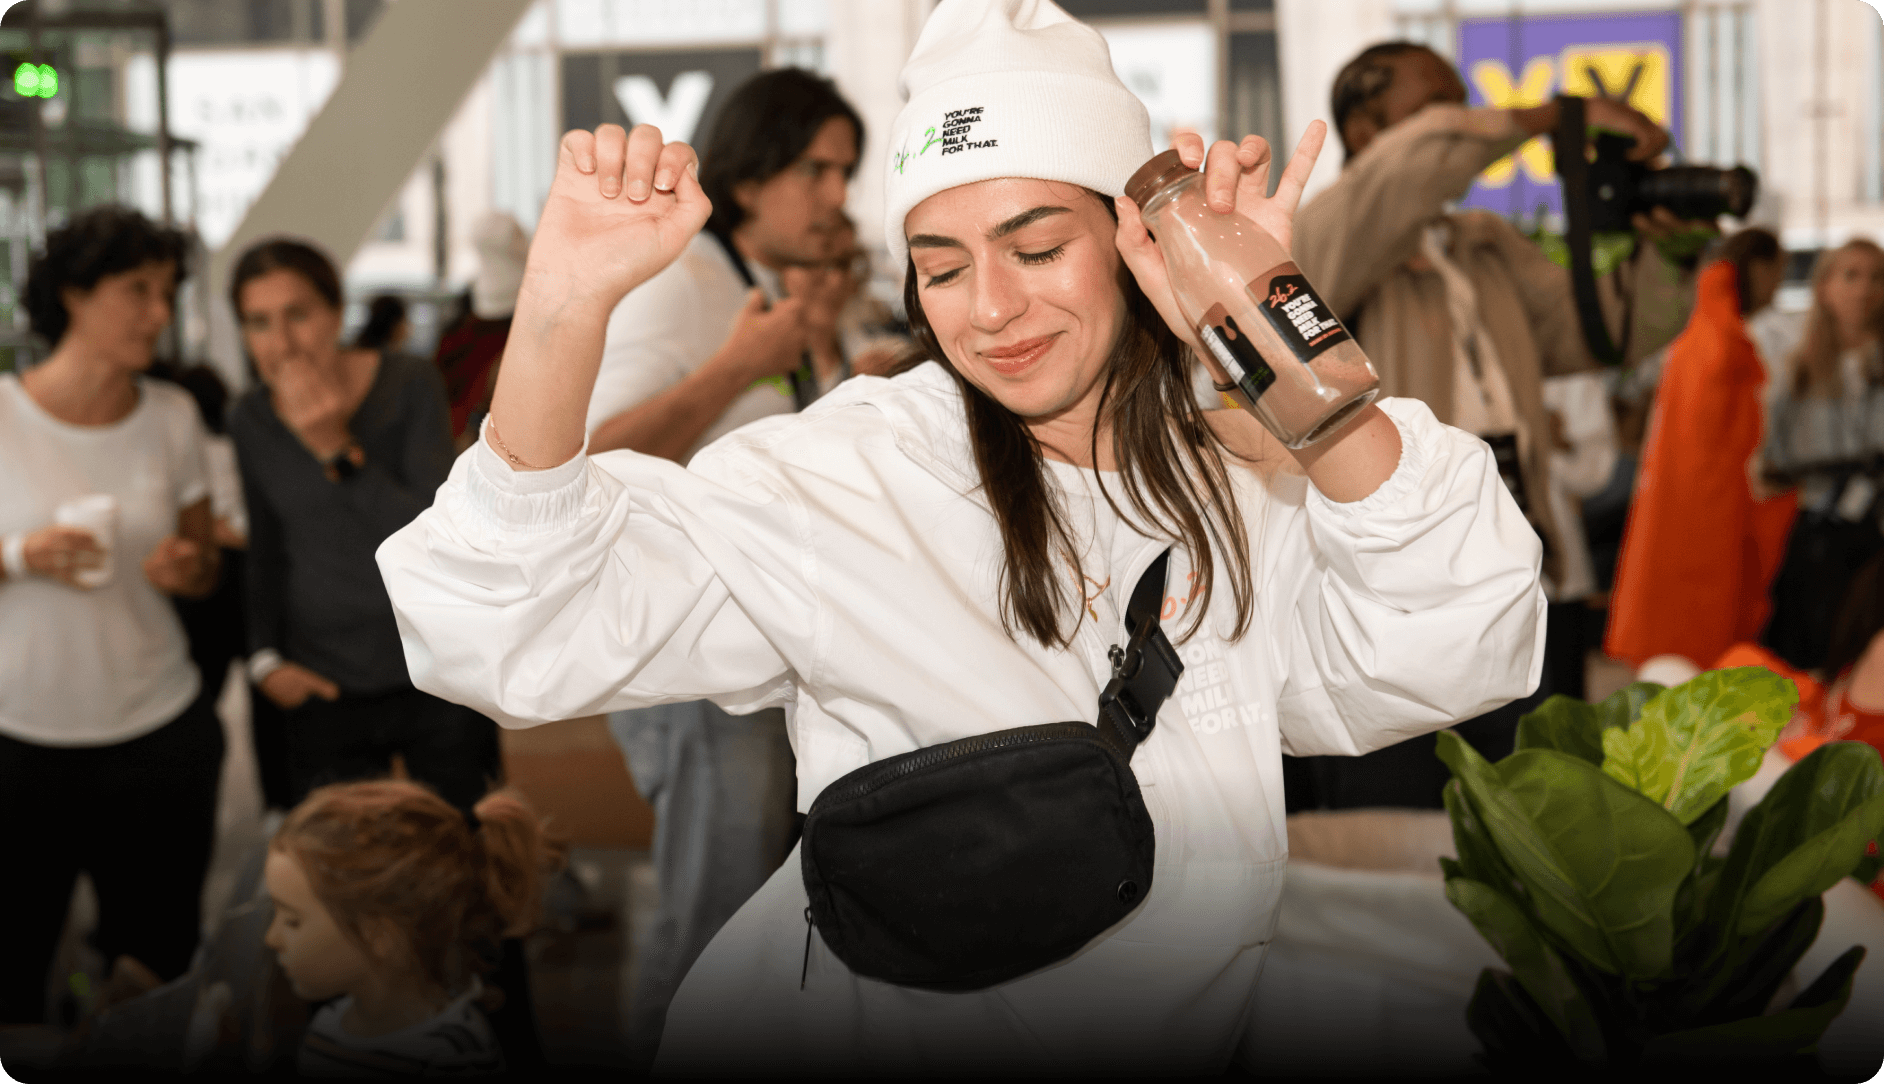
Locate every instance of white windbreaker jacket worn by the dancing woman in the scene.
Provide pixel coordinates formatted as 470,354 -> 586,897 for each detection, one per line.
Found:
379,364 -> 1545,1073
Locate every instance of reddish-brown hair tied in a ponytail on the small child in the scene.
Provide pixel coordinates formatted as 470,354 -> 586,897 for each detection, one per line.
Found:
269,779 -> 563,990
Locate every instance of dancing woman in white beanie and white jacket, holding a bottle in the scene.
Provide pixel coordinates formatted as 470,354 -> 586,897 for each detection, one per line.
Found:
381,0 -> 1545,1075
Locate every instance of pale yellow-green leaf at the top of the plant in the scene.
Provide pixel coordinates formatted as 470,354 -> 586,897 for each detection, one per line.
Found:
1601,665 -> 1799,824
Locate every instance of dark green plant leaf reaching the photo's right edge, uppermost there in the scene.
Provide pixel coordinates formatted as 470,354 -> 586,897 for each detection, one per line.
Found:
1709,741 -> 1884,937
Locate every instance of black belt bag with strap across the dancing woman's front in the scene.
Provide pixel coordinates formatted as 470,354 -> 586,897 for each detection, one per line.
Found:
801,550 -> 1183,990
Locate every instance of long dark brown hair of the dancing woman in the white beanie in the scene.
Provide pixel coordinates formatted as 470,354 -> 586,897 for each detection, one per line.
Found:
902,194 -> 1255,647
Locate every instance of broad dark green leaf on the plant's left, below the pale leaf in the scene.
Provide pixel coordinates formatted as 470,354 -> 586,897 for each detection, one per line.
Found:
1439,731 -> 1694,978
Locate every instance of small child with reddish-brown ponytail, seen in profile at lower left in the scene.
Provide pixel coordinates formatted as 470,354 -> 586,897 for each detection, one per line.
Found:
266,780 -> 561,1076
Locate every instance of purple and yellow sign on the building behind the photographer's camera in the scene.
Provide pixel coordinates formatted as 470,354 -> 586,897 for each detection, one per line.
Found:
1458,11 -> 1682,217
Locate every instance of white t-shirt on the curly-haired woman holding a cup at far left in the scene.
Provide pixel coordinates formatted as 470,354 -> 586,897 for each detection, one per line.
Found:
0,373 -> 209,747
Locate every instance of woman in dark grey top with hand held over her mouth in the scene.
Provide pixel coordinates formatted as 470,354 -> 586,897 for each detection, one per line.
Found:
230,241 -> 501,809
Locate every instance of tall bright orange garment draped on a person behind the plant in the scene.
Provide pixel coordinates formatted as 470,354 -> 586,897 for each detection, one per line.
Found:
1603,262 -> 1795,665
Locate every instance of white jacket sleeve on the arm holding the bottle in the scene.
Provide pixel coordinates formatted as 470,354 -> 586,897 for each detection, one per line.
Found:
1266,400 -> 1545,756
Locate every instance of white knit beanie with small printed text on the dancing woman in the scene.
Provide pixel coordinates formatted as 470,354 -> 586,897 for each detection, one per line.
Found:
884,0 -> 1151,266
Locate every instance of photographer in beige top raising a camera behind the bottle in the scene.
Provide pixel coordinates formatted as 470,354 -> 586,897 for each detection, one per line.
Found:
1289,41 -> 1684,809
